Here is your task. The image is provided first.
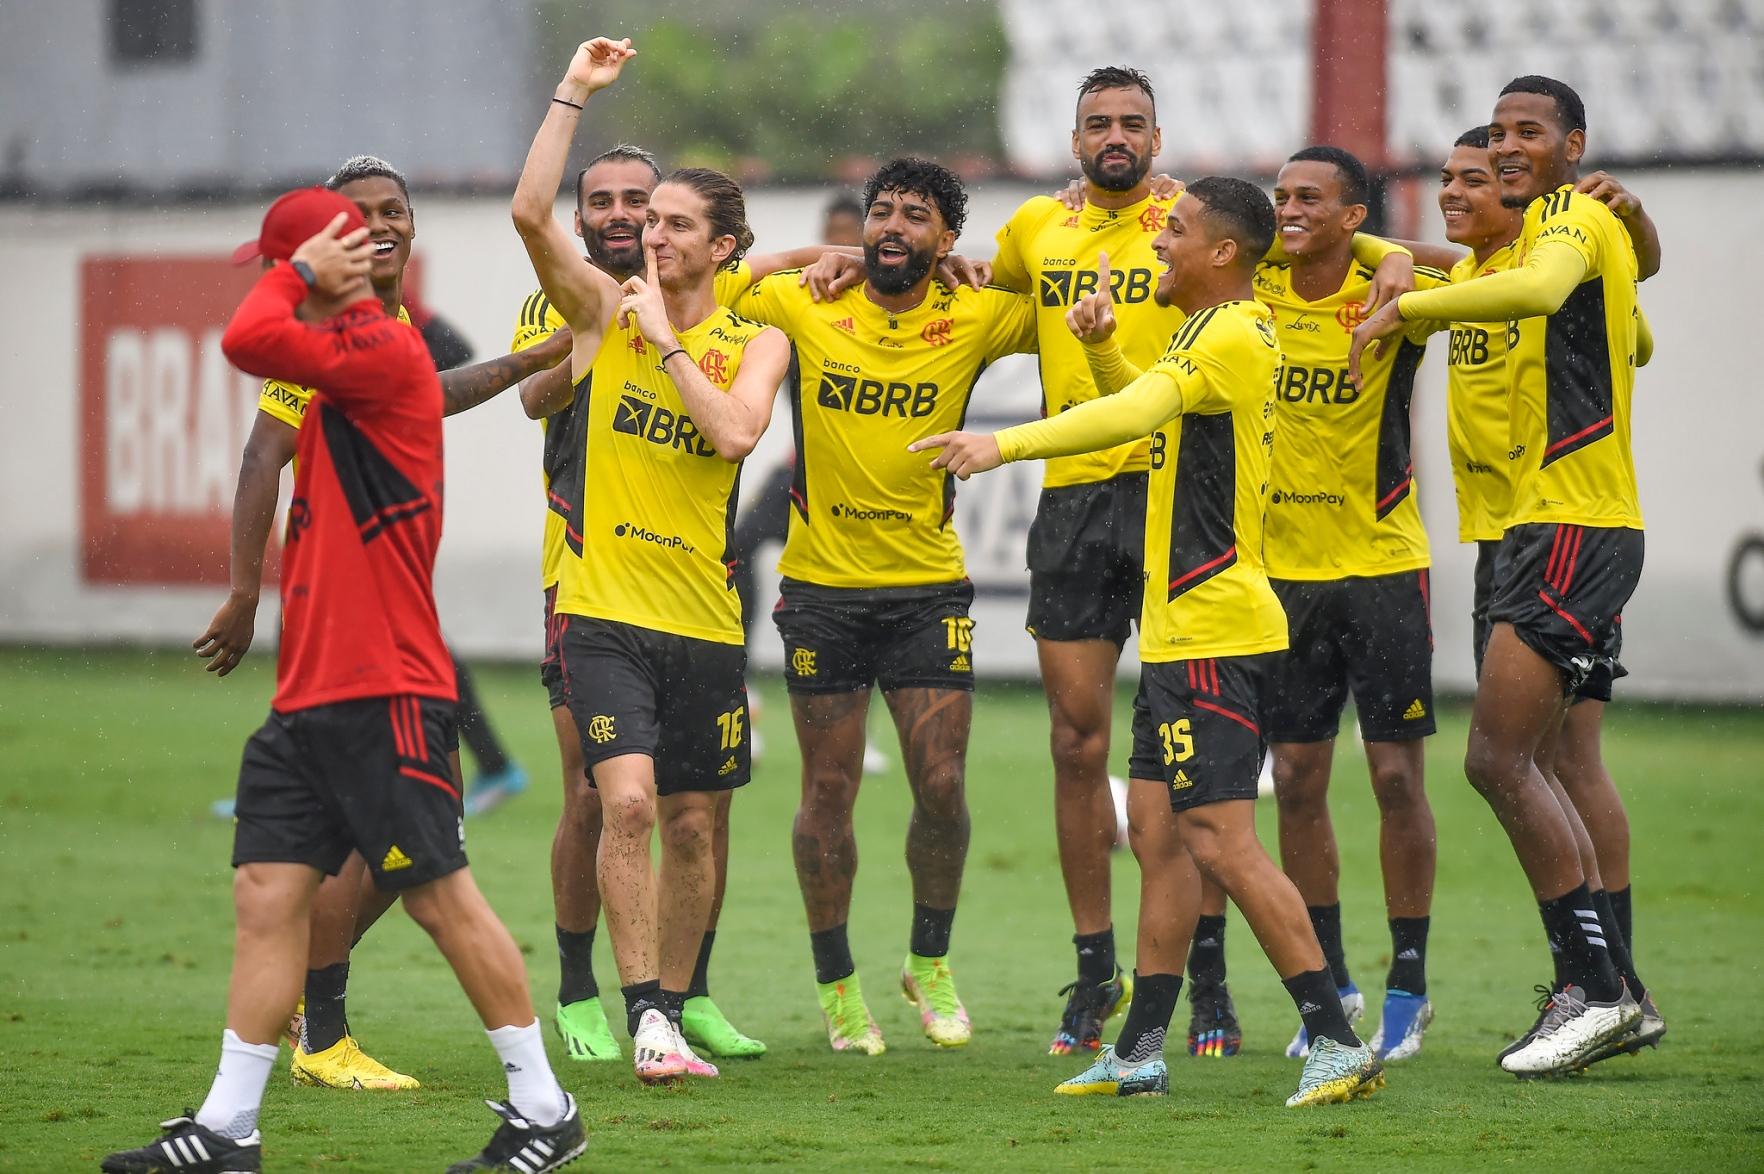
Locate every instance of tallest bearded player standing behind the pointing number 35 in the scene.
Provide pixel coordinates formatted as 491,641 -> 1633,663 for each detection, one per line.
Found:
993,65 -> 1185,1056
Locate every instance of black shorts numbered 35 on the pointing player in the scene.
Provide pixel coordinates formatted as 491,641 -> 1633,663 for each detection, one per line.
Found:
1127,652 -> 1275,811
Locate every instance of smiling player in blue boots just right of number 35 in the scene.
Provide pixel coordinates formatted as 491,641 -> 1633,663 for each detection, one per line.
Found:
1256,146 -> 1446,1059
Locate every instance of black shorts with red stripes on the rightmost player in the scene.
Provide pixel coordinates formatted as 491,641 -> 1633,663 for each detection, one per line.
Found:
1489,522 -> 1644,700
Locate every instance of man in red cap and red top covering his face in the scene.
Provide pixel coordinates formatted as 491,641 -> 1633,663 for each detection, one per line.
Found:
102,189 -> 587,1172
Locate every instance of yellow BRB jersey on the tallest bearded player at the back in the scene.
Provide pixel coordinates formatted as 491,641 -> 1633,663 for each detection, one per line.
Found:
993,194 -> 1182,488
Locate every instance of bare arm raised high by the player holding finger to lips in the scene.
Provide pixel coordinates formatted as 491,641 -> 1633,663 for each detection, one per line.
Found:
512,37 -> 637,338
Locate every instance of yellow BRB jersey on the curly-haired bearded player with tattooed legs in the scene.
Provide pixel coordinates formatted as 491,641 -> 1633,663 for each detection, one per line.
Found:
736,270 -> 1035,587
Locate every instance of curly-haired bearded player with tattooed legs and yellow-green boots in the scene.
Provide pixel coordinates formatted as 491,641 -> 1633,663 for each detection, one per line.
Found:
736,159 -> 1035,1056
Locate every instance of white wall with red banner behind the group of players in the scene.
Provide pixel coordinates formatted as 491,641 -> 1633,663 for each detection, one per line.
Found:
0,171 -> 1764,702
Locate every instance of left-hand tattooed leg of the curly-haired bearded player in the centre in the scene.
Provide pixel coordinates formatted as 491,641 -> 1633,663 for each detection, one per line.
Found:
790,689 -> 870,933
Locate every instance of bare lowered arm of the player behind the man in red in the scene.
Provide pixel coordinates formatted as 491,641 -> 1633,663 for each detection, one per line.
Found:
191,412 -> 300,677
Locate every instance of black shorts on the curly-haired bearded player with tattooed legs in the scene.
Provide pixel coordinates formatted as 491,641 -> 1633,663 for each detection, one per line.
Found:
773,578 -> 974,693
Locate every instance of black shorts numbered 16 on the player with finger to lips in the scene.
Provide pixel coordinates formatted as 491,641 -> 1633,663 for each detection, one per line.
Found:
559,615 -> 753,795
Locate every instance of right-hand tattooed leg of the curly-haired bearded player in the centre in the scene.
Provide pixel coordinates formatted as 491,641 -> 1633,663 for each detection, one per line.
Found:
886,689 -> 974,910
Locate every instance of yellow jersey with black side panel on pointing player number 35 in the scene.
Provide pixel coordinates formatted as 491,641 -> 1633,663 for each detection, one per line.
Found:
1140,301 -> 1286,661
